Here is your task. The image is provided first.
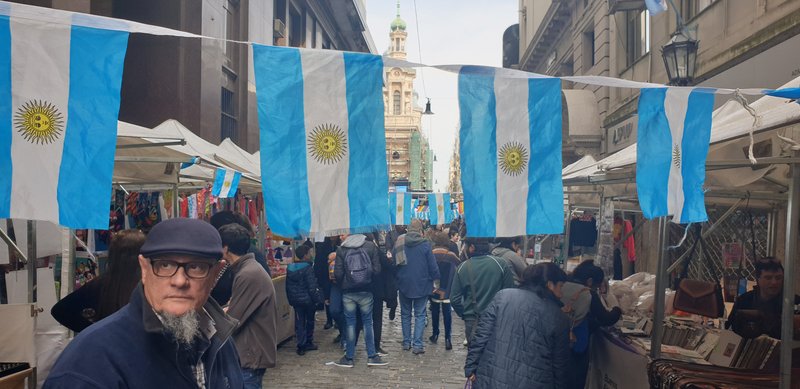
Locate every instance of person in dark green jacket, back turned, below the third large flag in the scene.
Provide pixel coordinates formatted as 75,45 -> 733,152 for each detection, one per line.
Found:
450,238 -> 514,342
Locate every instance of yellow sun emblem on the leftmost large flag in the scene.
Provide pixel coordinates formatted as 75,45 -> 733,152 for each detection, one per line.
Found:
14,100 -> 64,144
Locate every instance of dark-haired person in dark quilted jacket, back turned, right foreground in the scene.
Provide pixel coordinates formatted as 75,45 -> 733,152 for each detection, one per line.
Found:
464,263 -> 569,388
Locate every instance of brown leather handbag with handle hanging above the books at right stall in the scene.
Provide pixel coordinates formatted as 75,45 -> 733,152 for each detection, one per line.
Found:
672,224 -> 725,318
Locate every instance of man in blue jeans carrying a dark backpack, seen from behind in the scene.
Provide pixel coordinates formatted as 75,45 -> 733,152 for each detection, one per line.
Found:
334,234 -> 387,367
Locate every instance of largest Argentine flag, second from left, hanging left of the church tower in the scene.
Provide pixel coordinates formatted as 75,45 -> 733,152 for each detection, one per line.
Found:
253,44 -> 389,236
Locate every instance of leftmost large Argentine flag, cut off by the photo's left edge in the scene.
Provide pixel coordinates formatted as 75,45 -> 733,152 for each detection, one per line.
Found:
0,3 -> 128,230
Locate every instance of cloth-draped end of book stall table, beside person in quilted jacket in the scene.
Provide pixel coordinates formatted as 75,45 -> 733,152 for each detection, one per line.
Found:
586,330 -> 650,389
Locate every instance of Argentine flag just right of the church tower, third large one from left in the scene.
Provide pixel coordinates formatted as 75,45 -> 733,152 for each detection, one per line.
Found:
458,67 -> 564,237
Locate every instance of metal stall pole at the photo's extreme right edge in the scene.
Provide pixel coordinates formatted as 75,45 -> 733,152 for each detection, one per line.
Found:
780,156 -> 800,389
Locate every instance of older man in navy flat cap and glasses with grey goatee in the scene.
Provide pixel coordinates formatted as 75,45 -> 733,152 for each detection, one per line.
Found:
44,219 -> 243,389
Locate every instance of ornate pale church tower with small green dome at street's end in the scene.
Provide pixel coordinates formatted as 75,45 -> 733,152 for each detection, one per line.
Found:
383,1 -> 433,191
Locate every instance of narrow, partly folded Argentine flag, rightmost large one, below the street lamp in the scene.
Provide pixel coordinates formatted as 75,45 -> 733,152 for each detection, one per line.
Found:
636,88 -> 714,223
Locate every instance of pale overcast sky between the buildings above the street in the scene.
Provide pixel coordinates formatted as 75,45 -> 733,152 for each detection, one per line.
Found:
366,0 -> 519,192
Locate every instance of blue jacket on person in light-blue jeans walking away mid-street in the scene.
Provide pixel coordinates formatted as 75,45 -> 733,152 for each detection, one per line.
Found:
397,232 -> 439,299
